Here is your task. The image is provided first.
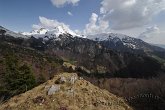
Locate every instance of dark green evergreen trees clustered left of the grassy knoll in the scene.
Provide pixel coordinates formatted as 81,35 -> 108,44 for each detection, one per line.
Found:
5,55 -> 36,96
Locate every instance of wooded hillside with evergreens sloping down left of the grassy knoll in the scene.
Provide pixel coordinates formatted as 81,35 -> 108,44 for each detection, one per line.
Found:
0,40 -> 63,102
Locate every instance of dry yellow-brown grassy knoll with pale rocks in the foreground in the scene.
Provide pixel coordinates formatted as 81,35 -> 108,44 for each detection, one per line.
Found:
0,73 -> 131,110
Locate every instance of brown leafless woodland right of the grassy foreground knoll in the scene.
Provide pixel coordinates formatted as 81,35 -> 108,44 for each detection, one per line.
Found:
82,74 -> 165,110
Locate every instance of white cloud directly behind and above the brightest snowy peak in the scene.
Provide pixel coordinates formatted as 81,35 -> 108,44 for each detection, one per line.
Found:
32,16 -> 69,29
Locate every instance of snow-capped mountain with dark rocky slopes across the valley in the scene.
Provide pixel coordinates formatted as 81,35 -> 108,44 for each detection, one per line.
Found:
0,25 -> 165,77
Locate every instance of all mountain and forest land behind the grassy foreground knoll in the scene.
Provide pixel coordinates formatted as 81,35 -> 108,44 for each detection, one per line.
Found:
0,25 -> 165,110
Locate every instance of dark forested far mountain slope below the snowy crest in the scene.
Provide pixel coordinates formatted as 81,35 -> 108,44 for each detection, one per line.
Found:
2,25 -> 165,77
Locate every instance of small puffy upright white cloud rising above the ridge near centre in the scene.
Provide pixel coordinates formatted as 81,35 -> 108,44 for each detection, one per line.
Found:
84,13 -> 109,34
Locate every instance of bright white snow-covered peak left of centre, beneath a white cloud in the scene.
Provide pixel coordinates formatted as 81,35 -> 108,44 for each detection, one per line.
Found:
22,25 -> 81,40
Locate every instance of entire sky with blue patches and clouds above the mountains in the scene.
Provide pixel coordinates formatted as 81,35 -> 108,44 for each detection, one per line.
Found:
0,0 -> 165,44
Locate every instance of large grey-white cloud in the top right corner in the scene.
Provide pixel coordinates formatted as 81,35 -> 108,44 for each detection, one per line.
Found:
100,0 -> 165,30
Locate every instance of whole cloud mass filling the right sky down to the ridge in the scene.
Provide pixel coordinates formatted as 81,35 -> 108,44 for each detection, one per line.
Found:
84,0 -> 165,44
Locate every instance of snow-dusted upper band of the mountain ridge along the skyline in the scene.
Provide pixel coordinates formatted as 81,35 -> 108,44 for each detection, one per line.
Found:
1,26 -> 165,51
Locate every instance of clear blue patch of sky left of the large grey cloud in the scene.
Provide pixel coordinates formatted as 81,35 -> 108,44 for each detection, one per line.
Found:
0,0 -> 100,31
